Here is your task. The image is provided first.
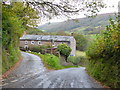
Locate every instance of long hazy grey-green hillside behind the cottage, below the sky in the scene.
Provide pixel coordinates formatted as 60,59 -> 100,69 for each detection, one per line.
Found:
38,13 -> 115,34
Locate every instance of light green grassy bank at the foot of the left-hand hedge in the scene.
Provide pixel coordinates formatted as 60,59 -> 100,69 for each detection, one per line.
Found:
2,48 -> 21,74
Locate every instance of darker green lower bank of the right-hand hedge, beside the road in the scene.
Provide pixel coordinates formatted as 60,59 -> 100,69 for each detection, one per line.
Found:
87,59 -> 120,88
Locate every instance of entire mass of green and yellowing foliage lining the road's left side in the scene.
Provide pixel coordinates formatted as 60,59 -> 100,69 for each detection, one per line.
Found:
2,2 -> 38,74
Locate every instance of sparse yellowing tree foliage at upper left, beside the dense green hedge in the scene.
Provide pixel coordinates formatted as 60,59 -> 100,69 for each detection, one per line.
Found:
10,2 -> 40,29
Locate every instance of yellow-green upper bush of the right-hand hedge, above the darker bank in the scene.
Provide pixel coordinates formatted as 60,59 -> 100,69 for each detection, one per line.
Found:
87,19 -> 120,59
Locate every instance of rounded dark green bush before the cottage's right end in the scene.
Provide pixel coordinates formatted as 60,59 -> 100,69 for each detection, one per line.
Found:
57,44 -> 72,62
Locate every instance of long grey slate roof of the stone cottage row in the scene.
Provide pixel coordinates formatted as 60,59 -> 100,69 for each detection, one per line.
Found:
20,35 -> 73,41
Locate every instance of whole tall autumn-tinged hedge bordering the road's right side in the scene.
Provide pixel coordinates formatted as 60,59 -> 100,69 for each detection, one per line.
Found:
86,19 -> 120,88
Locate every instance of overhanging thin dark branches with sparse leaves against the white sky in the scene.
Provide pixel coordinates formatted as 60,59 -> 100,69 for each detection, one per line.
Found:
4,0 -> 106,19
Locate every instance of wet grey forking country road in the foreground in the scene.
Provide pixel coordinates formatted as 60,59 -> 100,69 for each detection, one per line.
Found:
3,52 -> 102,88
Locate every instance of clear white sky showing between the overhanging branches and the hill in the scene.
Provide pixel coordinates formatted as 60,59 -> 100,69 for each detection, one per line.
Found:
38,0 -> 120,25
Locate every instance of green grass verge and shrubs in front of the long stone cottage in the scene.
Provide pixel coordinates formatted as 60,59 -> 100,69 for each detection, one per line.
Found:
27,44 -> 78,70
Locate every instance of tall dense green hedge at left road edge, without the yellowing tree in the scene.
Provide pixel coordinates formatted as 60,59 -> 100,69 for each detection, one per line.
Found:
2,5 -> 24,73
